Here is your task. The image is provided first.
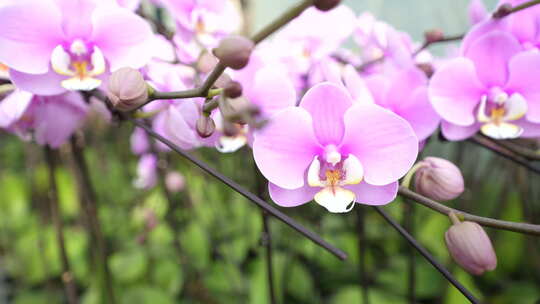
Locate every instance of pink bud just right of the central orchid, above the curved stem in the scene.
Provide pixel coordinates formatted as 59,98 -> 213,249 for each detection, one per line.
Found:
414,157 -> 465,201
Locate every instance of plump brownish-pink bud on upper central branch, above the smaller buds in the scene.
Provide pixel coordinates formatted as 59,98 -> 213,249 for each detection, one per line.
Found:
213,35 -> 255,70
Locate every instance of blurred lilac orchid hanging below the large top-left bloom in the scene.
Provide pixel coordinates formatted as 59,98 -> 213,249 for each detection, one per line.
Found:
0,90 -> 88,148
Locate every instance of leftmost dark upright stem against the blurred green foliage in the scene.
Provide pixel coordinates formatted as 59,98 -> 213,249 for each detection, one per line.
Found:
45,146 -> 79,304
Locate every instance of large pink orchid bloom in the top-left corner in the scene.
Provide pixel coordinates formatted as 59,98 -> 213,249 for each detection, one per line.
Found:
0,0 -> 153,95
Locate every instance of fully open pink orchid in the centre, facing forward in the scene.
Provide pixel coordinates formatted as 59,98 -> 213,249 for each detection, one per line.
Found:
253,83 -> 418,212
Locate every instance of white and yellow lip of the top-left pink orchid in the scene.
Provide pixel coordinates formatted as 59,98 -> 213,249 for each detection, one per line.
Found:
51,39 -> 106,91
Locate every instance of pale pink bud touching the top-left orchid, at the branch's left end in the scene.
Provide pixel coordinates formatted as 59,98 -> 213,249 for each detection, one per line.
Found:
107,68 -> 148,112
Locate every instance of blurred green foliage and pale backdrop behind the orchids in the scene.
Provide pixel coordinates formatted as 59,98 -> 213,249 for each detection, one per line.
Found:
0,0 -> 540,304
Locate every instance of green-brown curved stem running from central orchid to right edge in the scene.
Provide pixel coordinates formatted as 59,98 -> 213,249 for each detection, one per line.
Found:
398,187 -> 540,236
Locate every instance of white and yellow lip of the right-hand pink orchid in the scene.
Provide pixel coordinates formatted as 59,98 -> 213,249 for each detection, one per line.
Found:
477,91 -> 528,139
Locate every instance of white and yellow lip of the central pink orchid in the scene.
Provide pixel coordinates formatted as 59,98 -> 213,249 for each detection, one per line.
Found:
307,152 -> 364,213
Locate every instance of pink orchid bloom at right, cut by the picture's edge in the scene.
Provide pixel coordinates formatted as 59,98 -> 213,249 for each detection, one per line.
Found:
429,31 -> 540,140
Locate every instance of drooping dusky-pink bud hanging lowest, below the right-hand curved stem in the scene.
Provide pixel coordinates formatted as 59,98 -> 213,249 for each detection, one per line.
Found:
444,221 -> 497,275
